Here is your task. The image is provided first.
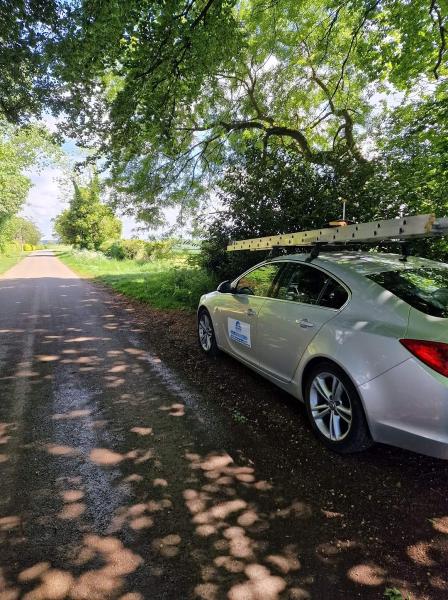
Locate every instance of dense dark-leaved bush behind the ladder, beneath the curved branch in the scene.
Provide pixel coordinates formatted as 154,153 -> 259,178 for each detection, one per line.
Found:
201,147 -> 392,279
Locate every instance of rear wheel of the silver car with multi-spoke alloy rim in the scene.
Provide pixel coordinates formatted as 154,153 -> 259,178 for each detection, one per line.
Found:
304,361 -> 373,454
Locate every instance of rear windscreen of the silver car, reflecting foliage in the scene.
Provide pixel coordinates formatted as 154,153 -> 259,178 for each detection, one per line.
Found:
367,267 -> 448,318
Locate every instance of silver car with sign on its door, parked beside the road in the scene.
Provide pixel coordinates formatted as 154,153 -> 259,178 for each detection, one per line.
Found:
198,252 -> 448,458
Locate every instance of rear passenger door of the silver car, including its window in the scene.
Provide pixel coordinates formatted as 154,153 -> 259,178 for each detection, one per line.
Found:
257,262 -> 348,382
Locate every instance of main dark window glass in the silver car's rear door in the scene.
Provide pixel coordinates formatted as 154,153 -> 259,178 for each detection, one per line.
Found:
275,263 -> 327,304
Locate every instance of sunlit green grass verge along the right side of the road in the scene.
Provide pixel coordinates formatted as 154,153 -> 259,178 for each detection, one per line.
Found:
55,249 -> 217,310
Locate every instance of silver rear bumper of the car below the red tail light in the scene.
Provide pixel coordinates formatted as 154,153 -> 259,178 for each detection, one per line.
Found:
358,358 -> 448,459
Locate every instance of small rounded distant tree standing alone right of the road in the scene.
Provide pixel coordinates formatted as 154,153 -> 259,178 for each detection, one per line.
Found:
54,175 -> 121,250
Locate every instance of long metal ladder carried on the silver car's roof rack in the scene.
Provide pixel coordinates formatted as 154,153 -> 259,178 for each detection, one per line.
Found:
227,214 -> 448,260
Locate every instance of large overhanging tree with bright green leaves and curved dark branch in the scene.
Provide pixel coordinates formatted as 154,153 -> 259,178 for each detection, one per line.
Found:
60,0 -> 447,223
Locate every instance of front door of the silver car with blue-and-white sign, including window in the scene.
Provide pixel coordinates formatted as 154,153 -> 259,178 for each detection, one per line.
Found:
216,263 -> 281,365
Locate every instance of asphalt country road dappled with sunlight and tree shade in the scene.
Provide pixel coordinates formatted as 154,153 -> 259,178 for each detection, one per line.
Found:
0,252 -> 448,600
